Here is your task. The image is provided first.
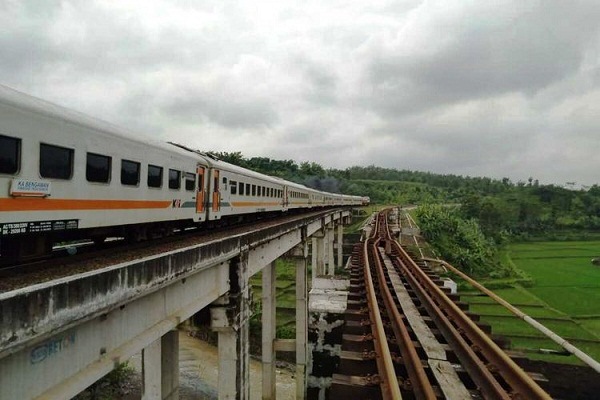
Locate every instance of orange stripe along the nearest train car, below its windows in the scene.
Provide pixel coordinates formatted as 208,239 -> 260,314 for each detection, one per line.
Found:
0,197 -> 171,212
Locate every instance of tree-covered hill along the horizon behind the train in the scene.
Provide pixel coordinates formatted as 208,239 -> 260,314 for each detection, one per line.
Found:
211,152 -> 600,238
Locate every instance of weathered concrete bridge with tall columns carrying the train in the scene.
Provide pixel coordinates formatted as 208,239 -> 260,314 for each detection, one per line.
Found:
0,209 -> 351,400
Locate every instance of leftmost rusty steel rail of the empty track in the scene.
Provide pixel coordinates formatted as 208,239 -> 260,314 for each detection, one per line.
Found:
363,217 -> 402,400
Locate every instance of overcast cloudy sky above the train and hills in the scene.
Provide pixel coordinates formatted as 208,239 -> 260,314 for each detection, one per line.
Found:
0,0 -> 600,185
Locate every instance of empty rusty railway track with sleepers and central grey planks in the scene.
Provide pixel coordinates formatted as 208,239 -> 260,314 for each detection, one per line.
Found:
331,211 -> 551,399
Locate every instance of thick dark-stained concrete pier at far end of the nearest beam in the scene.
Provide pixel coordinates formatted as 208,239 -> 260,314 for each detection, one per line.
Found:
210,254 -> 252,400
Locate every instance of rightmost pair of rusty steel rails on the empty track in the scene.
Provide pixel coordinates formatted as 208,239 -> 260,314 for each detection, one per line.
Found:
388,232 -> 551,399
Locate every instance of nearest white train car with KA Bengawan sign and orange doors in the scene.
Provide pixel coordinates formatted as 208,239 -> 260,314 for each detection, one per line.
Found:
0,86 -> 213,256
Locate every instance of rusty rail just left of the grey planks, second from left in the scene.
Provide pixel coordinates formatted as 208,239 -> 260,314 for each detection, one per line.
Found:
373,215 -> 436,399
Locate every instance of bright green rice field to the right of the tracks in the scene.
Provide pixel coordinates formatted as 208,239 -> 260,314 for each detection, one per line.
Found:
461,241 -> 600,364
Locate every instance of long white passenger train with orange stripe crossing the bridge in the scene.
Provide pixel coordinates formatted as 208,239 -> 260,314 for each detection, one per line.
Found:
0,85 -> 368,264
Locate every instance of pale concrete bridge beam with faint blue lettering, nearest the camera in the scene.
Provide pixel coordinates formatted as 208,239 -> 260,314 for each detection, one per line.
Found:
0,264 -> 229,399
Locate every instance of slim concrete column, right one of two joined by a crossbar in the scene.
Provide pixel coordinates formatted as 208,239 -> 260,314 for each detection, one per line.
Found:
295,244 -> 308,400
